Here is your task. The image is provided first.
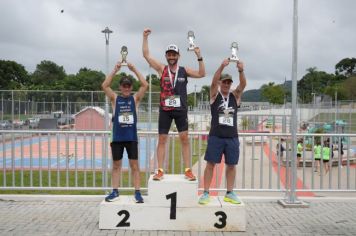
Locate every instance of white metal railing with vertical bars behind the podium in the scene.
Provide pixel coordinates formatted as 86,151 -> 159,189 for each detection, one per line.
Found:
0,130 -> 356,192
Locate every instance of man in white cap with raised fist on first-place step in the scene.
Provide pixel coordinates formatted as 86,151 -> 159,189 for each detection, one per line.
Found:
142,29 -> 205,181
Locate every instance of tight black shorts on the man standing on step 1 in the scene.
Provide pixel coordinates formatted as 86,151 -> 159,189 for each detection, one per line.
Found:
158,110 -> 188,134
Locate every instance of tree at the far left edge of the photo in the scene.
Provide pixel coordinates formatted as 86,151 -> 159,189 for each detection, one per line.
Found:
0,60 -> 30,90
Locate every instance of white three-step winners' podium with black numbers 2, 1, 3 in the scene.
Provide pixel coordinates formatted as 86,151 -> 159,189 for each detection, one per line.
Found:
99,175 -> 246,231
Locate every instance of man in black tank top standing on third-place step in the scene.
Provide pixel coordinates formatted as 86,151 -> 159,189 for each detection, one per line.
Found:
199,59 -> 246,204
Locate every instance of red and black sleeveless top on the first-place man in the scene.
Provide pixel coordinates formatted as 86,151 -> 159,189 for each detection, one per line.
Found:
160,66 -> 188,111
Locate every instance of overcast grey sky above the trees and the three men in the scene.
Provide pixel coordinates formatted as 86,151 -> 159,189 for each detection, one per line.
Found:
0,0 -> 356,91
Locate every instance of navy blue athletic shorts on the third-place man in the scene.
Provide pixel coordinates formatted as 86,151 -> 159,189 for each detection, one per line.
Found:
204,136 -> 240,165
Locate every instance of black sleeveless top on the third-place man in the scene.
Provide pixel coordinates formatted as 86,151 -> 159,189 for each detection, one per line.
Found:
209,92 -> 238,138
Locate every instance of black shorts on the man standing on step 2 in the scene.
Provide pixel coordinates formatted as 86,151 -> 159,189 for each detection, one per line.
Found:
110,141 -> 138,161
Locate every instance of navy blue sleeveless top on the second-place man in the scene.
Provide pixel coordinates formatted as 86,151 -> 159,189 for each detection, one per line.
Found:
112,95 -> 138,142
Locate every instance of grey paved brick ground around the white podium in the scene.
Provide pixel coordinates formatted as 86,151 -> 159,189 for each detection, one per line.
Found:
0,195 -> 356,236
